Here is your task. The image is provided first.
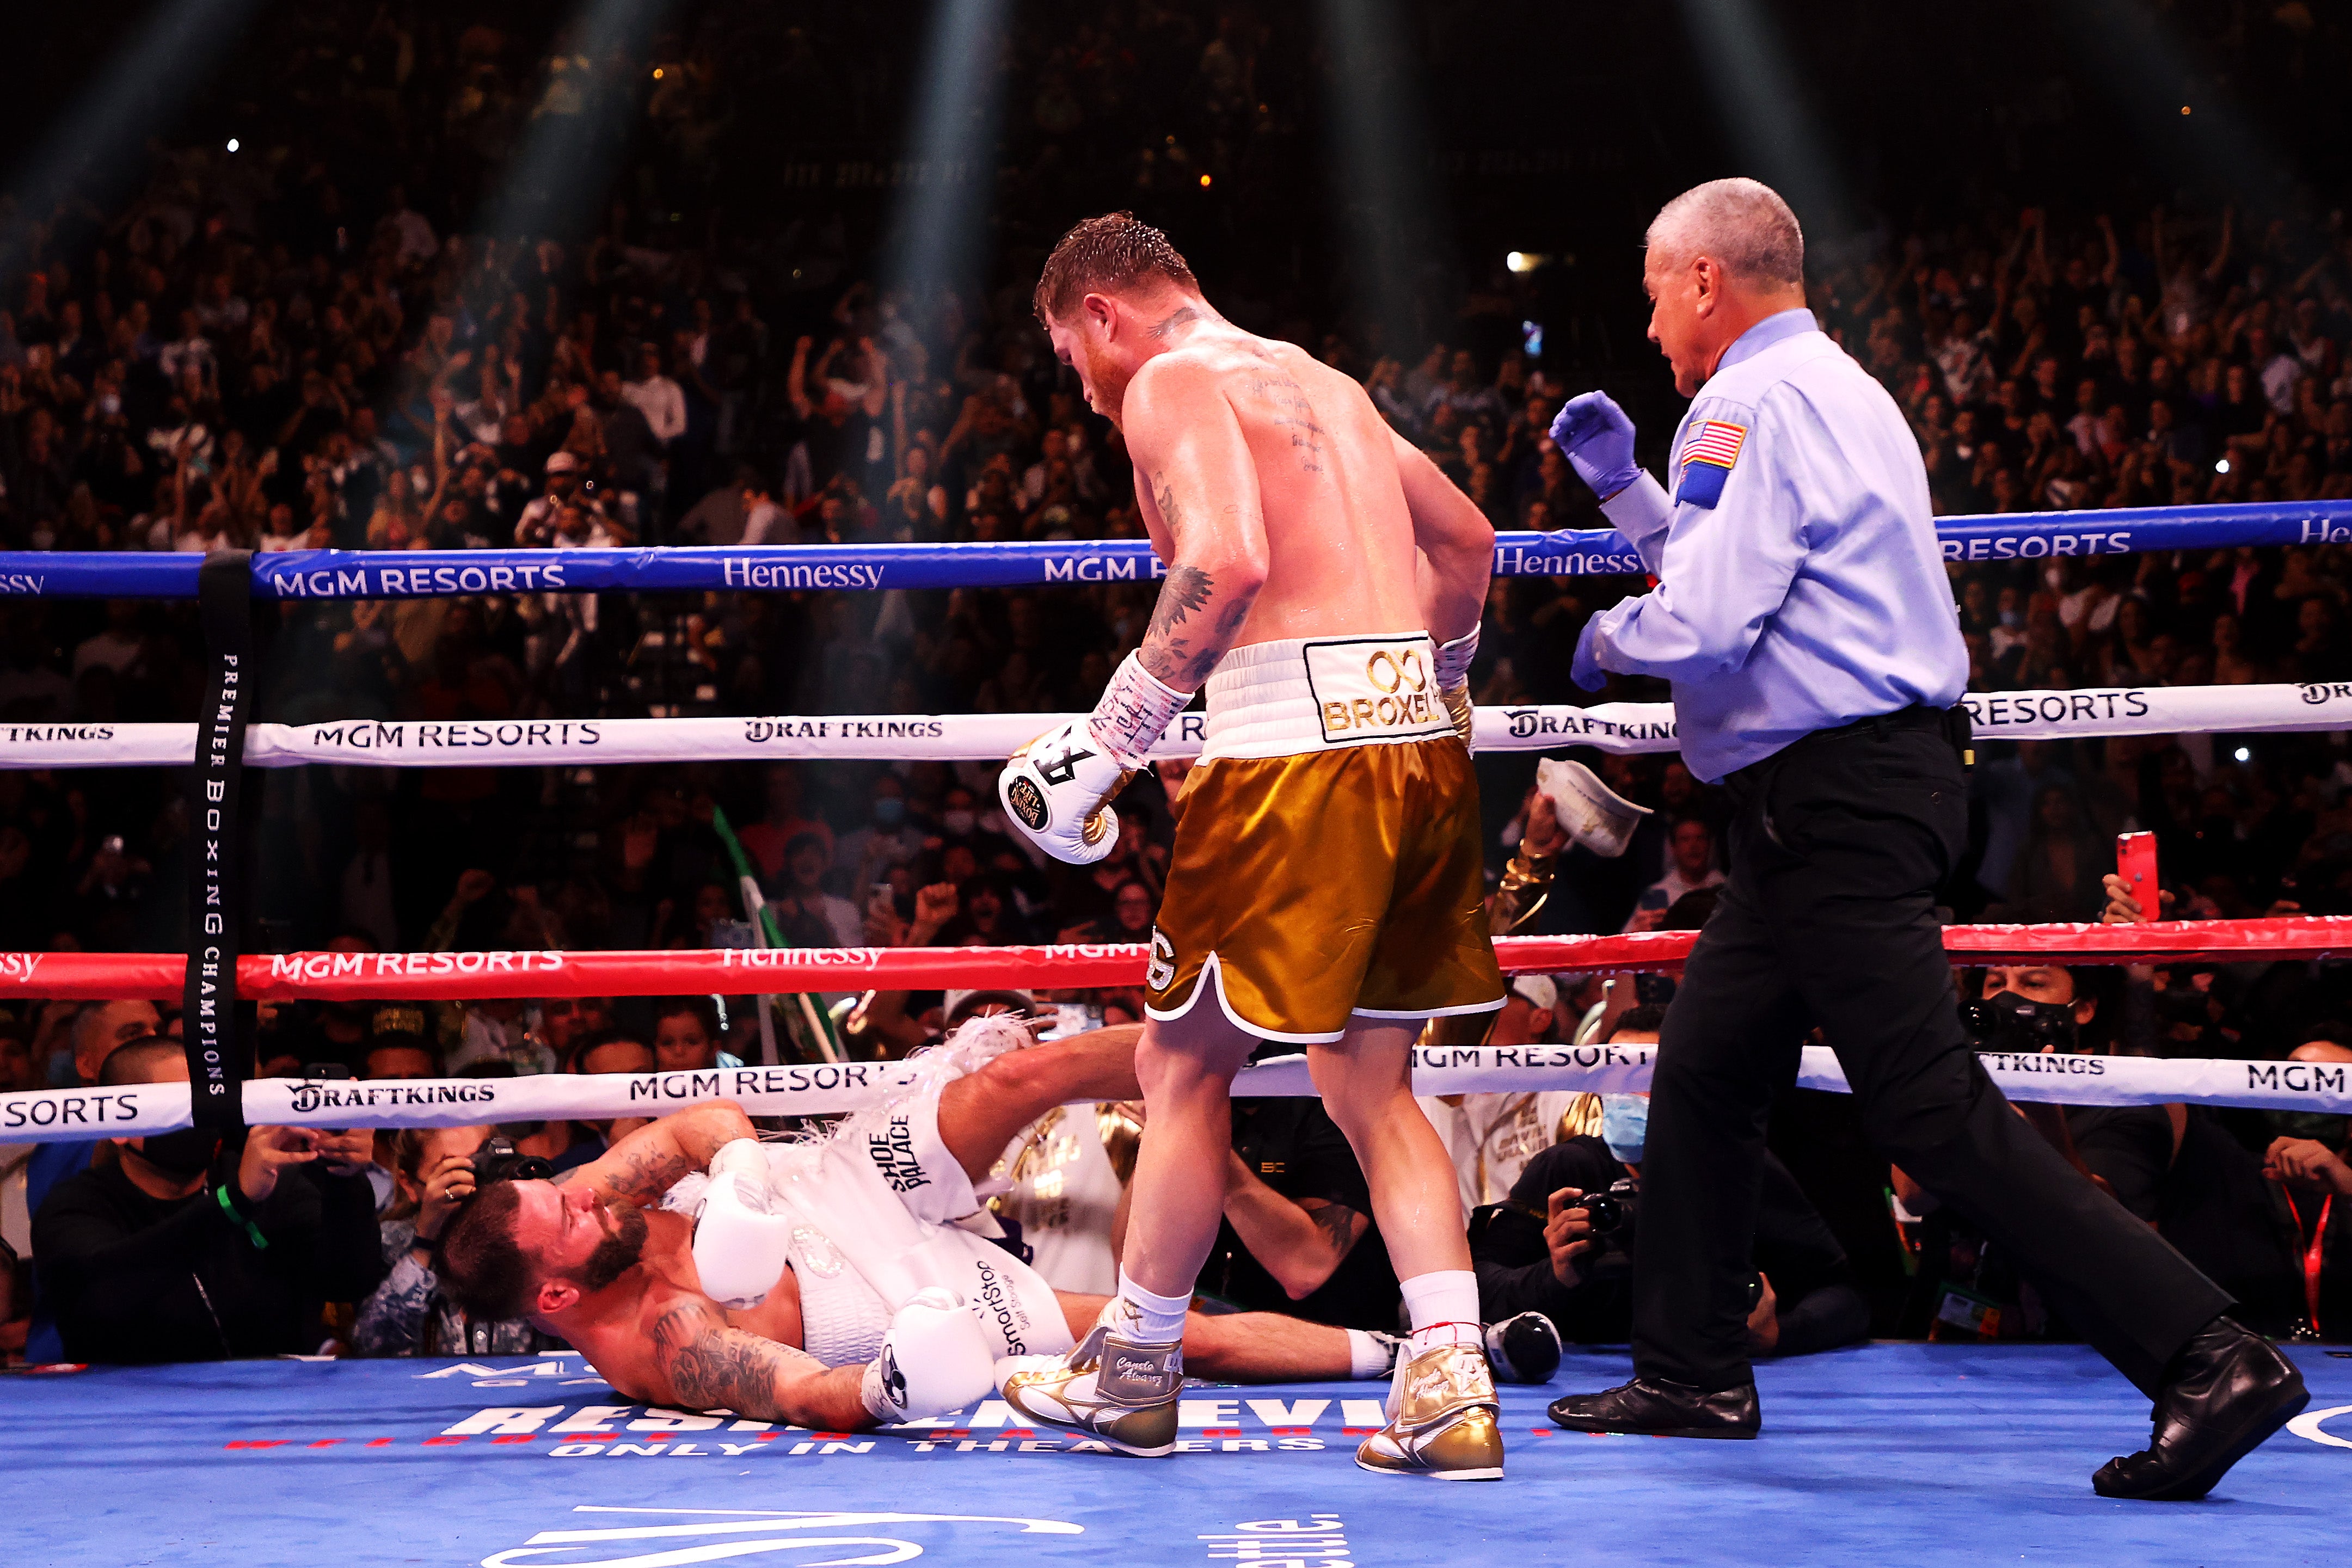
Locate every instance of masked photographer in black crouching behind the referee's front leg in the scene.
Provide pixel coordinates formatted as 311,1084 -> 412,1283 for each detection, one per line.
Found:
1470,1006 -> 1870,1356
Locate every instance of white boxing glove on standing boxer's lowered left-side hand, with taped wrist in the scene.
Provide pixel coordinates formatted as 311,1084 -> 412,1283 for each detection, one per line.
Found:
997,654 -> 1193,865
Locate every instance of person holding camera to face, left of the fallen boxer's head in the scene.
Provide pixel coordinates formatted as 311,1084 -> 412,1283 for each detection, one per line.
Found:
351,1123 -> 567,1356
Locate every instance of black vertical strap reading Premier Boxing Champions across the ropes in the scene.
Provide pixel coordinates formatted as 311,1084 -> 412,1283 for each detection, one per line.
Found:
181,550 -> 256,1131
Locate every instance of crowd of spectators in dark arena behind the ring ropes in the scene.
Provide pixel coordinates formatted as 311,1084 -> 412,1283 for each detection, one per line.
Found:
0,5 -> 2352,1361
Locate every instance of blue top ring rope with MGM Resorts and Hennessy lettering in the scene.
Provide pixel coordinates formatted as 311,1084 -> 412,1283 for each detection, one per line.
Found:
0,501 -> 2352,599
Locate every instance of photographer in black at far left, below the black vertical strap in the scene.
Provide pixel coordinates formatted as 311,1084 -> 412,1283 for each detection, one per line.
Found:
33,1037 -> 383,1363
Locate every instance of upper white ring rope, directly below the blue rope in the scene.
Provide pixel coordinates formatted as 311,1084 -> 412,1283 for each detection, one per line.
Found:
0,684 -> 2352,768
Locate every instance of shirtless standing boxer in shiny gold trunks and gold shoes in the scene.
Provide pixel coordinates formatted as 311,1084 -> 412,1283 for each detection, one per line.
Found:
999,214 -> 1503,1479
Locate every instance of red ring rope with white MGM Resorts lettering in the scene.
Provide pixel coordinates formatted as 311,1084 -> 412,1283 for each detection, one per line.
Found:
18,917 -> 2352,1001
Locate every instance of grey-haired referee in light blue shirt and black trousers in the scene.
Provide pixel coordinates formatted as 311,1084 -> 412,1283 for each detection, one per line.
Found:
1550,179 -> 2307,1497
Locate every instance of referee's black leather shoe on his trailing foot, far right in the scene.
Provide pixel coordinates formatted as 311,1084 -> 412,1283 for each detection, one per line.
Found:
2091,1317 -> 2312,1502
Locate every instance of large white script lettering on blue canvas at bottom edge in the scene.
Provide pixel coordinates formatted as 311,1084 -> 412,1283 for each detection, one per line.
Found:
482,1502 -> 1086,1568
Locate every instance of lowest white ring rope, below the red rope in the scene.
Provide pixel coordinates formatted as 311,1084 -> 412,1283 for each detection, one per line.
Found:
0,1046 -> 2352,1142
